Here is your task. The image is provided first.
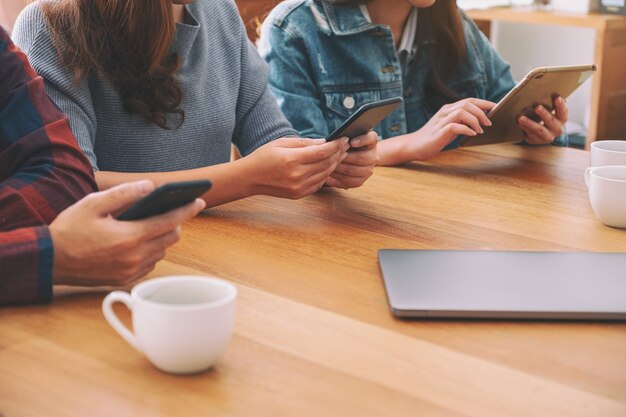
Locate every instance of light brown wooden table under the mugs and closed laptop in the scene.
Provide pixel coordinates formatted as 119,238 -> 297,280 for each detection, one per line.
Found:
0,145 -> 626,417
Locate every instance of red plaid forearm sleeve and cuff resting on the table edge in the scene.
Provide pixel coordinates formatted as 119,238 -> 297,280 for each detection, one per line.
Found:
0,226 -> 53,306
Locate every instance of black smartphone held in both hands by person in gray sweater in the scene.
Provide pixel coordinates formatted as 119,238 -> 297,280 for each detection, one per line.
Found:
326,97 -> 402,141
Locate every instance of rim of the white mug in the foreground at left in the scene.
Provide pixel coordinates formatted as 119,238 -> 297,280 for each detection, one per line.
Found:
130,275 -> 237,311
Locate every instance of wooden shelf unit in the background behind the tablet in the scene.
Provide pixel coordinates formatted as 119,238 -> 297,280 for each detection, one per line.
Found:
468,8 -> 626,149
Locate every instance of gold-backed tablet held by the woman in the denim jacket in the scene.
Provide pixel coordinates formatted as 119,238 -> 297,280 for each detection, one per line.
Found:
459,65 -> 596,146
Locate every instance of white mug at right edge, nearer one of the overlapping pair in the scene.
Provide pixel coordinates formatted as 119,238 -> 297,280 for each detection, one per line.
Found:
585,166 -> 626,228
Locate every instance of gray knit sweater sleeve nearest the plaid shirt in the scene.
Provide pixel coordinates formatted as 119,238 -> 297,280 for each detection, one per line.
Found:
13,2 -> 97,170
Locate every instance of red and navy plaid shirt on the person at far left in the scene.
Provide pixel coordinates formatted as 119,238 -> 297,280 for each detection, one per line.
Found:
0,27 -> 96,305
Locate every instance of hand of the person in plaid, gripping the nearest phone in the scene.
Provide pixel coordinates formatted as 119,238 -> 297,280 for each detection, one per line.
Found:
49,180 -> 205,286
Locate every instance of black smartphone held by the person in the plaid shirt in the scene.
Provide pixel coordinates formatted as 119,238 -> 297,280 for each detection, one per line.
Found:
117,180 -> 212,220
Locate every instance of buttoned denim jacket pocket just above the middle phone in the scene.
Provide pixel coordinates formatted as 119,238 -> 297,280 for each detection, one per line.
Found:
322,88 -> 380,132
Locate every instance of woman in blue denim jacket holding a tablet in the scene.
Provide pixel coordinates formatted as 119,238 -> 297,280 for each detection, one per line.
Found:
259,0 -> 568,165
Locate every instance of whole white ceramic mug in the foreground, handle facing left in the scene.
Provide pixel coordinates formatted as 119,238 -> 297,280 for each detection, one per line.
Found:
102,276 -> 237,374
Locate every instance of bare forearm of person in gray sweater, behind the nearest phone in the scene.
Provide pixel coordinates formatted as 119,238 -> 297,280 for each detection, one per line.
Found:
96,158 -> 256,207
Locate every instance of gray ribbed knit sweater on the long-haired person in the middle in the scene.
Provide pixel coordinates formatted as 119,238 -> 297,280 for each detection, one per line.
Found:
13,0 -> 296,172
